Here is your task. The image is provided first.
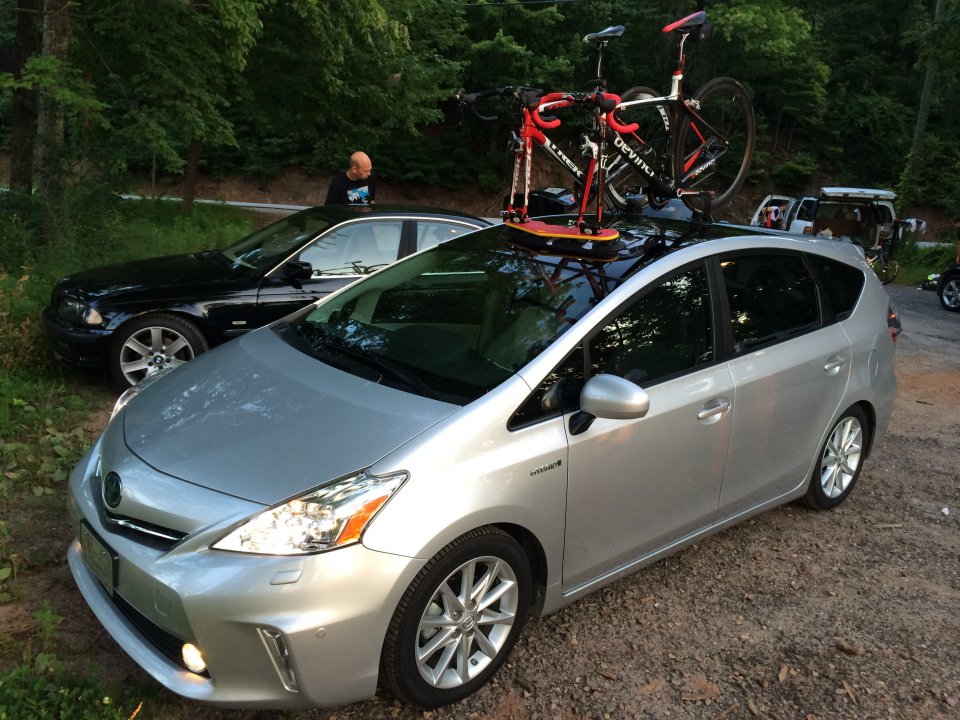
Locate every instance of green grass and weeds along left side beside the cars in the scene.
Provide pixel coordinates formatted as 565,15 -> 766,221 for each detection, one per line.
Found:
0,194 -> 252,720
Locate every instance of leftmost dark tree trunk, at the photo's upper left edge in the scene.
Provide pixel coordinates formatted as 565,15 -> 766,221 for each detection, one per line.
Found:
10,0 -> 40,196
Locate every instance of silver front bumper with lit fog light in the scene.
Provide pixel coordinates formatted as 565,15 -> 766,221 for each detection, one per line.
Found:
68,448 -> 424,708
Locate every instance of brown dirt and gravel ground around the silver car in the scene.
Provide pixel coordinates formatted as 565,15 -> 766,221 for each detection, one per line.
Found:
0,198 -> 960,720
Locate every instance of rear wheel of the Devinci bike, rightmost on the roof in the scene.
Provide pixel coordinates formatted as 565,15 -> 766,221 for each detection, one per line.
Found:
673,78 -> 756,217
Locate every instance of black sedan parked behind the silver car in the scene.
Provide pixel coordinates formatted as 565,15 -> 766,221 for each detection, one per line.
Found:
44,206 -> 490,387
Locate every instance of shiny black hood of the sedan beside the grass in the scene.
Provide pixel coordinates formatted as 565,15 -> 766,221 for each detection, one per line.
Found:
58,251 -> 239,301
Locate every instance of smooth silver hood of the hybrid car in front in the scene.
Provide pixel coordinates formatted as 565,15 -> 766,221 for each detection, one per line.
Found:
123,328 -> 459,505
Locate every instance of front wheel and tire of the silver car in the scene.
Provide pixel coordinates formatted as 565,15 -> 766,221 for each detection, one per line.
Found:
380,527 -> 531,708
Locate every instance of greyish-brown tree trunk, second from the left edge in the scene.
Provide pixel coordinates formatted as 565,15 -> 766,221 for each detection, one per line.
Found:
37,0 -> 70,242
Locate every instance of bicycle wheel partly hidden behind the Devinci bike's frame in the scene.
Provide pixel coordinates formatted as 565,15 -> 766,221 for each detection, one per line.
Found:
604,85 -> 670,210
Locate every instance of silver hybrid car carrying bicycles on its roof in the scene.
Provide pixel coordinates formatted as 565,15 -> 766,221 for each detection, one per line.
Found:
69,220 -> 896,708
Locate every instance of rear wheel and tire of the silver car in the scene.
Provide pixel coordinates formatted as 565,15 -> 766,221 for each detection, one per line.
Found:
806,405 -> 870,510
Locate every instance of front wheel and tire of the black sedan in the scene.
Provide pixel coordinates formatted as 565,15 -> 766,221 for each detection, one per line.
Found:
107,313 -> 209,389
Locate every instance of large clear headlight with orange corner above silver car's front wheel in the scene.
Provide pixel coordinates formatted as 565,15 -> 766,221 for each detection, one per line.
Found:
213,471 -> 409,555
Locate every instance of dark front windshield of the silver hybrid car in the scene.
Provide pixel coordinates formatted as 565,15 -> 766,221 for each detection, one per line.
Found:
284,228 -> 616,404
